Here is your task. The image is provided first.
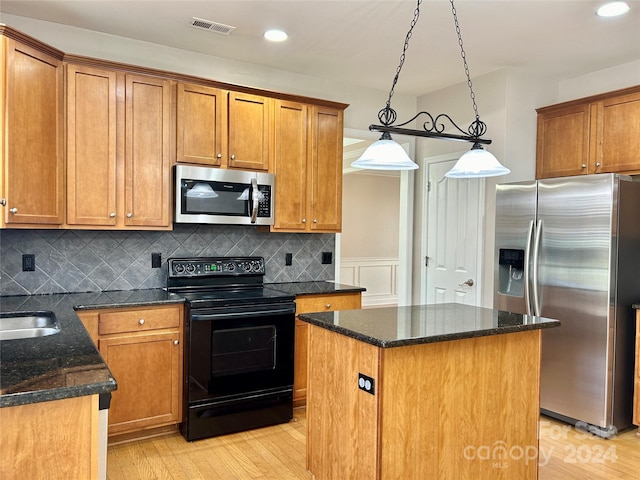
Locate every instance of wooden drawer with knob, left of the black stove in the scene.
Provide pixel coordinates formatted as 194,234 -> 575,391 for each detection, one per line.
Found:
98,305 -> 180,335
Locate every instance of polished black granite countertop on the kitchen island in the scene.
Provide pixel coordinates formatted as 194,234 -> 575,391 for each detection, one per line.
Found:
299,303 -> 560,348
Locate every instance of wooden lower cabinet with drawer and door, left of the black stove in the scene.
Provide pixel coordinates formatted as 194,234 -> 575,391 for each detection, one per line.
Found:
79,305 -> 183,437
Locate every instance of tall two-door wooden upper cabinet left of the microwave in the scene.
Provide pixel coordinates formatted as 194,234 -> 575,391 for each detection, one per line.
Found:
66,64 -> 172,229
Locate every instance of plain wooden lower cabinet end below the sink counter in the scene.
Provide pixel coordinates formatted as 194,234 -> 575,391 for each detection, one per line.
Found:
0,395 -> 98,480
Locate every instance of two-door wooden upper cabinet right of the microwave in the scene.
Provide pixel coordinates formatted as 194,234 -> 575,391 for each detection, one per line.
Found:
271,100 -> 343,232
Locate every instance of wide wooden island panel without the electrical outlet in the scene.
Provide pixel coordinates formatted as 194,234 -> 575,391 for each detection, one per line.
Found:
382,330 -> 541,480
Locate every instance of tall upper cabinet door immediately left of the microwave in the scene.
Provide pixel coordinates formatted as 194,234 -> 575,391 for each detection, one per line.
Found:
124,75 -> 171,227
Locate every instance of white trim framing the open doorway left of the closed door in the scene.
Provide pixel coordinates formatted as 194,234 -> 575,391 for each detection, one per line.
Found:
334,128 -> 415,306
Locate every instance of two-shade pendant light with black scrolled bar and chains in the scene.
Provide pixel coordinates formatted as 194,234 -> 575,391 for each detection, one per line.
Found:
351,0 -> 510,178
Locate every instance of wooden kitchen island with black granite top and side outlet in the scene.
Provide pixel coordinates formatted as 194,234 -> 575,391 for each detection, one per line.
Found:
300,304 -> 560,480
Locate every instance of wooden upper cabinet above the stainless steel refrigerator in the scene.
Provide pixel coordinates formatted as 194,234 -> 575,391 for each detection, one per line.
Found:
536,86 -> 640,178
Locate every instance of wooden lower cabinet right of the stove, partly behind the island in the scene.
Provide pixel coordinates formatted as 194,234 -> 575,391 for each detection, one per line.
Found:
293,292 -> 362,407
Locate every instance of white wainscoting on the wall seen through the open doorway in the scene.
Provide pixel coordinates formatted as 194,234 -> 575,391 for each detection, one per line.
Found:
340,257 -> 399,307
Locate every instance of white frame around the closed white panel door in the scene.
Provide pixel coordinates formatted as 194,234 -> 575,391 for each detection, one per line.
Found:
414,150 -> 487,306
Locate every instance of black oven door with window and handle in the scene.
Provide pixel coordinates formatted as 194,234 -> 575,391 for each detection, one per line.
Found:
188,302 -> 295,404
